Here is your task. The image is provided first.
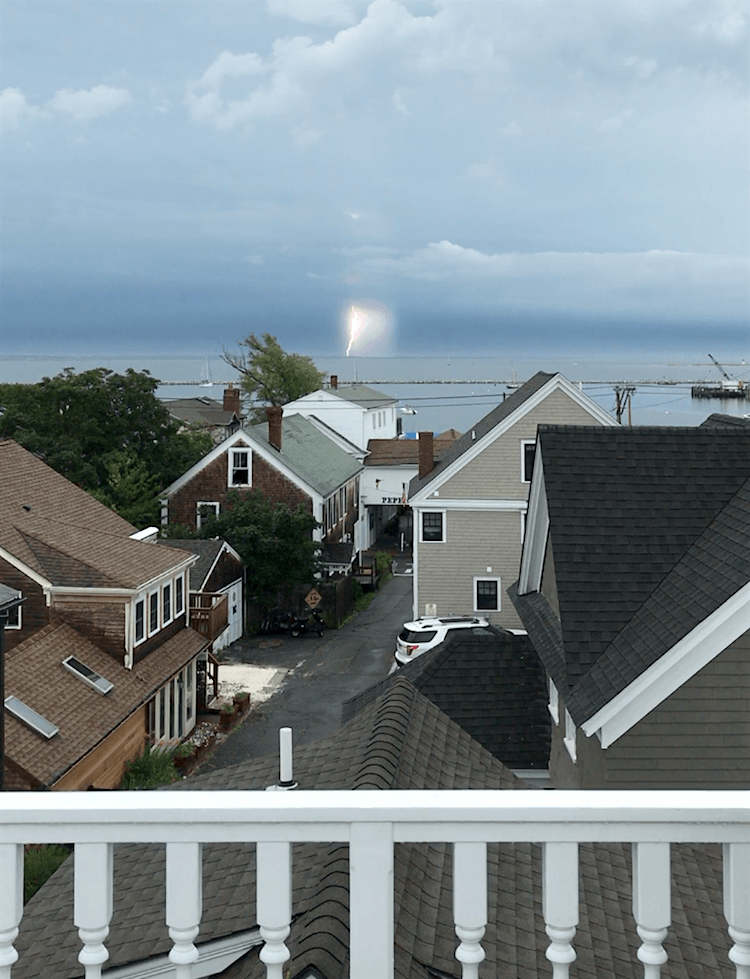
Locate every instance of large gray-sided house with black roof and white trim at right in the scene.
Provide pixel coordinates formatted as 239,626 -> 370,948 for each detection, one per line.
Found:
510,426 -> 750,789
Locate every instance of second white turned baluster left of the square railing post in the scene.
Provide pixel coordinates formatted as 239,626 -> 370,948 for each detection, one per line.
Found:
167,843 -> 203,979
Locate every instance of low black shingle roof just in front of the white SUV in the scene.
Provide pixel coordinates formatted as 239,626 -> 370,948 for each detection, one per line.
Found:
342,628 -> 551,769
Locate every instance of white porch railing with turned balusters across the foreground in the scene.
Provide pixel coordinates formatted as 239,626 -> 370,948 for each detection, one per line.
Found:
0,790 -> 750,979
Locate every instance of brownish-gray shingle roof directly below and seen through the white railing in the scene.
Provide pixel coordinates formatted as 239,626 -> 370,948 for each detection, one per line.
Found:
13,676 -> 734,979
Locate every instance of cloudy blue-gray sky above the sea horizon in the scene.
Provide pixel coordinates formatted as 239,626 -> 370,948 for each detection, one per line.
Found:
0,0 -> 750,364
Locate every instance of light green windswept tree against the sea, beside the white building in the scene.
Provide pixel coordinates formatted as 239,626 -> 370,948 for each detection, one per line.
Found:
222,333 -> 325,421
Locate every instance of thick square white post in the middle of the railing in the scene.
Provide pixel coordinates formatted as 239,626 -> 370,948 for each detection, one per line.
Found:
349,822 -> 393,979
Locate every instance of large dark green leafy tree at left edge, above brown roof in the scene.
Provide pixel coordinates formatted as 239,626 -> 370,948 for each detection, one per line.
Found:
0,367 -> 213,525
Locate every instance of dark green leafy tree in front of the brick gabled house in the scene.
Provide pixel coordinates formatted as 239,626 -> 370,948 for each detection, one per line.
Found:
164,490 -> 320,598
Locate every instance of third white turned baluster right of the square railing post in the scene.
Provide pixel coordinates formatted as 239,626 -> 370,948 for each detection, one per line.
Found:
633,843 -> 672,979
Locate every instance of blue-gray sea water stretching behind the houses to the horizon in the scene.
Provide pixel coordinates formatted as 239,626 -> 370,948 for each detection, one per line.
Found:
0,355 -> 750,433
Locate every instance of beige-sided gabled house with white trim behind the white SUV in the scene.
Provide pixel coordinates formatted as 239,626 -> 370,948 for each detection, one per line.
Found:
409,372 -> 616,628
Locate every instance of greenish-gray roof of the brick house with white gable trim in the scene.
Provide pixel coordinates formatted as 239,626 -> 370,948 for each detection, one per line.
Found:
245,415 -> 362,497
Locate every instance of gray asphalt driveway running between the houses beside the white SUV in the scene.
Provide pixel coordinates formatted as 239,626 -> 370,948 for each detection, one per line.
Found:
200,575 -> 412,773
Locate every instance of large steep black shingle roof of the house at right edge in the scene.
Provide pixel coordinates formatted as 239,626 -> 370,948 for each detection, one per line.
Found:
509,426 -> 750,724
